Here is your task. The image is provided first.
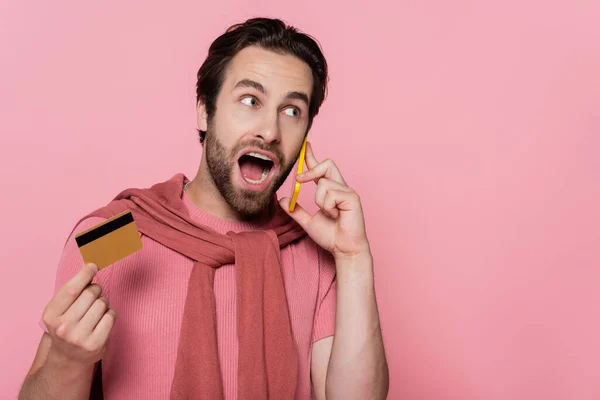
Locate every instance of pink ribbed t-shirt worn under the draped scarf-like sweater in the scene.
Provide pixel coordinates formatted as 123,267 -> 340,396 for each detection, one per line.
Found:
42,193 -> 336,400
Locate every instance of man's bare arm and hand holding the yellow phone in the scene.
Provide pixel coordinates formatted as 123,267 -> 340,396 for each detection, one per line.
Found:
280,144 -> 389,399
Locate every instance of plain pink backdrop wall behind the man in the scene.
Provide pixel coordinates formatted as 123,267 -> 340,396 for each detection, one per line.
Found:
0,0 -> 600,400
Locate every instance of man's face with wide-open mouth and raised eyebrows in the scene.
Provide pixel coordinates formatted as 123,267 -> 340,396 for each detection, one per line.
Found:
198,47 -> 313,217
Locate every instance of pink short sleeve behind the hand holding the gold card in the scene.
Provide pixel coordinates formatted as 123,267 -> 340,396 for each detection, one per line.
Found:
39,217 -> 110,333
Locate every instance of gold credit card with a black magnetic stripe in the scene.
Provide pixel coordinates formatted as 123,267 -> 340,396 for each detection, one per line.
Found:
75,211 -> 142,270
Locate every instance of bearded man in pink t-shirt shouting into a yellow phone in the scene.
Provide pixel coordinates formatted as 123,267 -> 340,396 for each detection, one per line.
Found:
20,18 -> 388,399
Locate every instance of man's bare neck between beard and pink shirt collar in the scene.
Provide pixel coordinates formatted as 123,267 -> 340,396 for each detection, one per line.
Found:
186,158 -> 273,222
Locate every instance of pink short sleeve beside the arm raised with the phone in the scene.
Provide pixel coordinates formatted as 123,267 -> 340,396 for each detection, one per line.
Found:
312,247 -> 337,343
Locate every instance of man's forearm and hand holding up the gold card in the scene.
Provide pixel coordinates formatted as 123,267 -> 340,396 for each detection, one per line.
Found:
19,265 -> 115,400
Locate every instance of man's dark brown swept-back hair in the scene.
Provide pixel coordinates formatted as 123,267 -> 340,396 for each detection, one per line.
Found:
196,18 -> 328,143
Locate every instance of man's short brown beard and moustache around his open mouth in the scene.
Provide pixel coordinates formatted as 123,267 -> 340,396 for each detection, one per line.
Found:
204,124 -> 299,219
